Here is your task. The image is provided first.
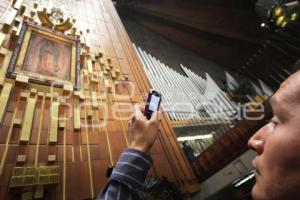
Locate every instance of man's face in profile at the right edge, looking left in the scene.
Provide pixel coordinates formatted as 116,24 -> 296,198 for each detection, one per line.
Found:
248,75 -> 300,200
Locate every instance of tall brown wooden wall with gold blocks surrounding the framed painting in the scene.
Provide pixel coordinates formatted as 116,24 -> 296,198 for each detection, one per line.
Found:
0,0 -> 198,199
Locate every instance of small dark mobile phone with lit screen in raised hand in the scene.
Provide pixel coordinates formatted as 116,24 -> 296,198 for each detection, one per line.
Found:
144,89 -> 161,120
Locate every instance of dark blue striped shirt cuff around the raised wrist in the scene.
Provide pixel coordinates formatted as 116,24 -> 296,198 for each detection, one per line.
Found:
110,148 -> 152,188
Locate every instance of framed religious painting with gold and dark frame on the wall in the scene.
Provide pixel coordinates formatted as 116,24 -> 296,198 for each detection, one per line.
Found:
7,22 -> 80,89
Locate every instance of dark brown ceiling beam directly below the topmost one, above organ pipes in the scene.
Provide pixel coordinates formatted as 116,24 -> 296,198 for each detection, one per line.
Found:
119,7 -> 257,70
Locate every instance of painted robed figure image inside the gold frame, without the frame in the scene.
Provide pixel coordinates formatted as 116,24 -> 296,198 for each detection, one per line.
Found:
23,34 -> 71,80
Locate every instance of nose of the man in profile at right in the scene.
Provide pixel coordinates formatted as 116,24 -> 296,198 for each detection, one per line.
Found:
248,126 -> 267,154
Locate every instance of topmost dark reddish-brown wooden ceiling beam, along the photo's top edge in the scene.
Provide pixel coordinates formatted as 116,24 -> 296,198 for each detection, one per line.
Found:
126,0 -> 264,44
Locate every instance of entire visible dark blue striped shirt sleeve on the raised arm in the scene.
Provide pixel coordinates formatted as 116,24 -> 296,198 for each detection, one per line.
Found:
97,148 -> 152,200
